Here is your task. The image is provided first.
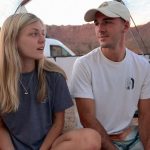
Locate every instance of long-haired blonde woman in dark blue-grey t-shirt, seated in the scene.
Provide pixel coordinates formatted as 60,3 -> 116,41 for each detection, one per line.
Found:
0,13 -> 101,150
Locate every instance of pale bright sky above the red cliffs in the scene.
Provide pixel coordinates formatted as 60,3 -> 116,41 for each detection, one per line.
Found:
0,0 -> 150,25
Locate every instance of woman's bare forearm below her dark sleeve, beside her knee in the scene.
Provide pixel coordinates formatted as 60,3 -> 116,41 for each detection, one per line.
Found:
40,112 -> 64,150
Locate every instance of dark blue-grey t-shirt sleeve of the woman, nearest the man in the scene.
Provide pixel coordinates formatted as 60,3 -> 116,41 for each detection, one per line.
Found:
54,74 -> 73,112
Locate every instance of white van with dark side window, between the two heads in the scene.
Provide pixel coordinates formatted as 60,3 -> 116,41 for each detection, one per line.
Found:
44,38 -> 75,57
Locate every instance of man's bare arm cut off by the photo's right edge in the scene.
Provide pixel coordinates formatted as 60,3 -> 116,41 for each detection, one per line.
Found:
138,99 -> 150,150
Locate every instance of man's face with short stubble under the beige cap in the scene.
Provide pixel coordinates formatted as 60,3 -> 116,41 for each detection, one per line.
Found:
94,12 -> 129,48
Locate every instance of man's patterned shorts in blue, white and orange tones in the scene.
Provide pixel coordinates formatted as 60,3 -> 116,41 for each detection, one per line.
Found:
113,126 -> 144,150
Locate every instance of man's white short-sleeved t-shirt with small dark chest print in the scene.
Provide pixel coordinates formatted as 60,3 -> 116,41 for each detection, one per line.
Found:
70,48 -> 150,134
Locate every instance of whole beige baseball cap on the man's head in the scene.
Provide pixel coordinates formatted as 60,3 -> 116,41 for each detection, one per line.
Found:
84,1 -> 130,22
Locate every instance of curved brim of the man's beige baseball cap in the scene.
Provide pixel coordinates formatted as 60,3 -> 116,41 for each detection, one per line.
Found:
84,8 -> 120,22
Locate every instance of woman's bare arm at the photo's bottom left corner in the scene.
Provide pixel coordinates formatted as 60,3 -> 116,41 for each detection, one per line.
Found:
0,118 -> 14,150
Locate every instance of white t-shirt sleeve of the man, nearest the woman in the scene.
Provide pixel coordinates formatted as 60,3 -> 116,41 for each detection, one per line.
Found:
70,59 -> 93,99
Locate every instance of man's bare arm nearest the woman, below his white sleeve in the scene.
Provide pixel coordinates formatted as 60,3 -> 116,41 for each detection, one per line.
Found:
75,98 -> 116,150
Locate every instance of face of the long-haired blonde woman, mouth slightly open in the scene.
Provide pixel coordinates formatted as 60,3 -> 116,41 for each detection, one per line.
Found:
17,21 -> 45,61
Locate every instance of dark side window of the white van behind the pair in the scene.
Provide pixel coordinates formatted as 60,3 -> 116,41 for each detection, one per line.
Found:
50,45 -> 71,57
